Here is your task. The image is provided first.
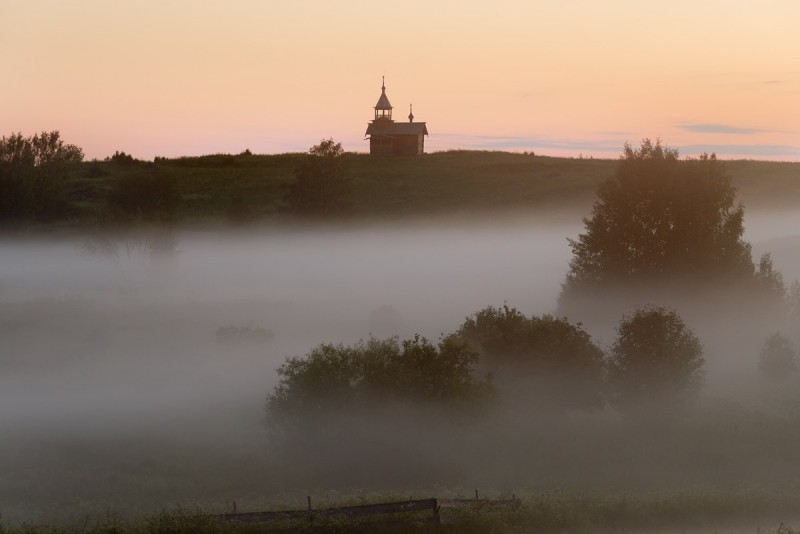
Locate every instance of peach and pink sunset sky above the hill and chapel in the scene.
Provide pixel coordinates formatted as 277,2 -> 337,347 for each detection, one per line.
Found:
0,0 -> 800,161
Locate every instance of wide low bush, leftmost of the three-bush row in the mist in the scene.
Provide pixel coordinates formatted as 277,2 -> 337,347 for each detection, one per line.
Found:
266,335 -> 492,434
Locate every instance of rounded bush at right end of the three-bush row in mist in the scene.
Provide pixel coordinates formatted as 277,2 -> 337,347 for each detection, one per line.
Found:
608,306 -> 704,411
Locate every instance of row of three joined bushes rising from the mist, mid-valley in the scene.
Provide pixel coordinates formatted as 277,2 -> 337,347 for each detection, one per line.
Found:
266,305 -> 705,436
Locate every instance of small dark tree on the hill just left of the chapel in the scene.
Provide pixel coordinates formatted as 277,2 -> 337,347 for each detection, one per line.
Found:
284,139 -> 351,218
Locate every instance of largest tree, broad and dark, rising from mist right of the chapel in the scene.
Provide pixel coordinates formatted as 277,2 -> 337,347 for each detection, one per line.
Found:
561,139 -> 754,310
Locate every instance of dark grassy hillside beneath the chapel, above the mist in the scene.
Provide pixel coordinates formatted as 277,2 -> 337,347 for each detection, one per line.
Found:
54,151 -> 800,225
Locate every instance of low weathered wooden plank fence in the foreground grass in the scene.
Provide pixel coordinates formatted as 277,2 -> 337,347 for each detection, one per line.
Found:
214,491 -> 521,523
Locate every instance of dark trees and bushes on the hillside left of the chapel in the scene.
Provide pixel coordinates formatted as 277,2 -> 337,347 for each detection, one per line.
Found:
0,131 -> 346,224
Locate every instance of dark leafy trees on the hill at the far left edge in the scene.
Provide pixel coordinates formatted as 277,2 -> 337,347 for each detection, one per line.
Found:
0,131 -> 83,220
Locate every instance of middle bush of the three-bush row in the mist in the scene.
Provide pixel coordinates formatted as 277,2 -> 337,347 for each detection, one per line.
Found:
456,305 -> 603,409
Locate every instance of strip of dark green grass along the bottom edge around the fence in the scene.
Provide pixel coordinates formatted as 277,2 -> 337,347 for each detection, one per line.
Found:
9,493 -> 800,534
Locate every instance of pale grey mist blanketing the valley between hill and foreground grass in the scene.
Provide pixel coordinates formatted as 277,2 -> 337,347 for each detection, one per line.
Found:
0,208 -> 800,521
